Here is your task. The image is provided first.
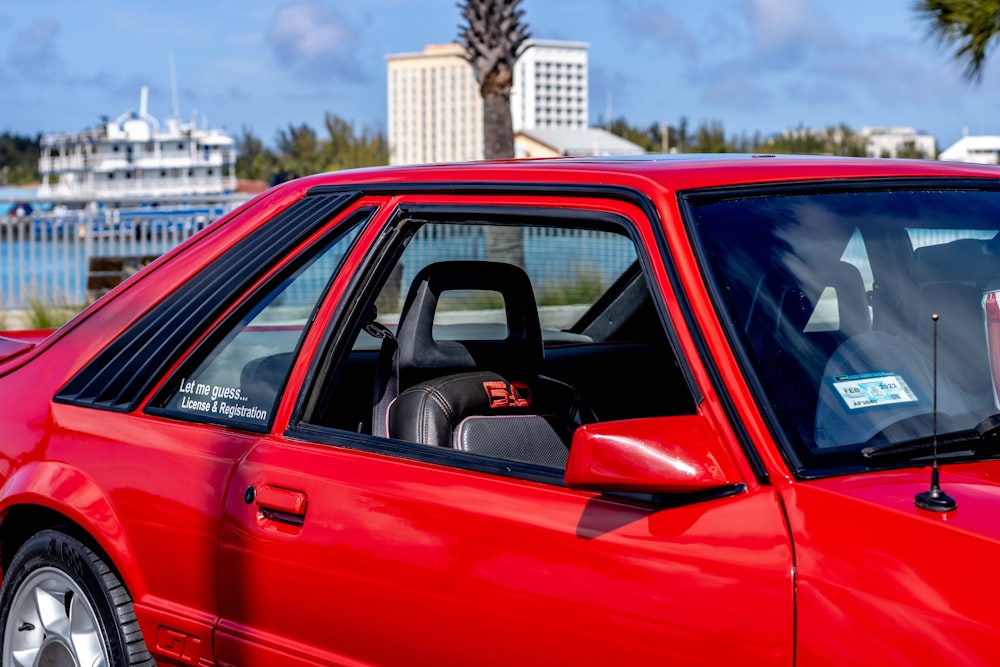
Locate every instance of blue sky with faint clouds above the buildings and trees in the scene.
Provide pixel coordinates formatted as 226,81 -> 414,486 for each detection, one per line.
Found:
0,0 -> 1000,149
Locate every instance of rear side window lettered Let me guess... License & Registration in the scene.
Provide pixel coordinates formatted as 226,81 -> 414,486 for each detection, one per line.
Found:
151,211 -> 371,429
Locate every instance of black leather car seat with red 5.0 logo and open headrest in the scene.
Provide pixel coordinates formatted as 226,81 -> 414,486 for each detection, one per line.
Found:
385,261 -> 582,467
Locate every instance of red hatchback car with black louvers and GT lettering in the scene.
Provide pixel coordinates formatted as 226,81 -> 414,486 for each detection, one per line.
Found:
0,156 -> 1000,667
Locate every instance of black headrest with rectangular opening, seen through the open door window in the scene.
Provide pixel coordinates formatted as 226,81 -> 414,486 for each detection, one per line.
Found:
396,261 -> 543,388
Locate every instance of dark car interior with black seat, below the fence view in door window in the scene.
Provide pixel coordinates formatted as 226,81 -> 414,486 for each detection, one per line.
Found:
308,219 -> 695,467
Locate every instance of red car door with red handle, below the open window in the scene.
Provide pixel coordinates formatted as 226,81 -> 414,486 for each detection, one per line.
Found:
215,198 -> 794,665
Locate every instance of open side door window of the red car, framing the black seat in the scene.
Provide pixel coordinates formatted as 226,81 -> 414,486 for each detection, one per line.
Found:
306,211 -> 694,467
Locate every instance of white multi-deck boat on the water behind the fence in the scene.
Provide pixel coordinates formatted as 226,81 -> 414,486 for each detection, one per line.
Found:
38,87 -> 236,201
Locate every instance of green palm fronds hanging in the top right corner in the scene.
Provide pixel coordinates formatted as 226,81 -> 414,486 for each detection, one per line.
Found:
914,0 -> 1000,82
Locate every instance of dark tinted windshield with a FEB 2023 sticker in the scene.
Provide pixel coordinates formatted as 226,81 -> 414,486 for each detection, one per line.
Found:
682,182 -> 1000,474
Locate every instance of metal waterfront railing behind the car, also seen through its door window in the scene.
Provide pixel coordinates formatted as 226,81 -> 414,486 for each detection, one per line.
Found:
0,198 -> 635,309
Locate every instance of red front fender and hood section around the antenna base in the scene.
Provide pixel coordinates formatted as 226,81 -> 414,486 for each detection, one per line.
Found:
782,468 -> 1000,665
